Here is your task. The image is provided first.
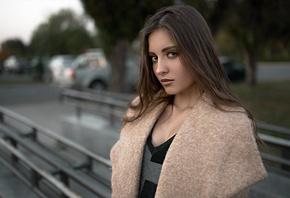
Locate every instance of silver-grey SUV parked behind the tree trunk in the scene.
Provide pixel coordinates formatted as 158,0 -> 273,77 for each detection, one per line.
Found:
73,49 -> 140,92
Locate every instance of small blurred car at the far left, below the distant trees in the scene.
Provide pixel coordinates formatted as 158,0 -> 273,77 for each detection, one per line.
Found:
4,55 -> 30,74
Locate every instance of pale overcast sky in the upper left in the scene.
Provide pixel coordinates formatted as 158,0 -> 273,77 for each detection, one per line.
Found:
0,0 -> 93,46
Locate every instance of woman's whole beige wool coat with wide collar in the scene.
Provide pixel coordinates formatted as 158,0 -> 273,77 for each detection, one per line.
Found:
111,96 -> 267,198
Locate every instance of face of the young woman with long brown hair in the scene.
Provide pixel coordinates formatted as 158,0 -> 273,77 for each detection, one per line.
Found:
148,28 -> 196,95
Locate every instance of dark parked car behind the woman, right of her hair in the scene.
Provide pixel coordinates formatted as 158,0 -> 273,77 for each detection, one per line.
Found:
219,56 -> 246,82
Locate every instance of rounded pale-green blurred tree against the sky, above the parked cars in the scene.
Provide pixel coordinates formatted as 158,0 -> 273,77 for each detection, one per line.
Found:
30,9 -> 94,56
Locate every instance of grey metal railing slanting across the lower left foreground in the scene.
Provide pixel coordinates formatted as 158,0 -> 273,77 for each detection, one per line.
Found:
0,106 -> 111,198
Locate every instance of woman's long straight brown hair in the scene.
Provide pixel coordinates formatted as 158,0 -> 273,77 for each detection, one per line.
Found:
123,5 -> 258,141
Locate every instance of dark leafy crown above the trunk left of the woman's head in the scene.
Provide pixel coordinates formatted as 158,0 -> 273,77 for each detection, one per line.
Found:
81,0 -> 174,56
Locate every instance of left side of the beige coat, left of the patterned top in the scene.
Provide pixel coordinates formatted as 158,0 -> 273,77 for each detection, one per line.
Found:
111,101 -> 165,198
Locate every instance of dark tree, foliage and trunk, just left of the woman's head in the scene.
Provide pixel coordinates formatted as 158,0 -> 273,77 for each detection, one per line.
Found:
81,0 -> 175,92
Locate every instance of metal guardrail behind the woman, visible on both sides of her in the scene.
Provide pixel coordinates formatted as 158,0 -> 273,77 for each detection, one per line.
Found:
61,89 -> 290,170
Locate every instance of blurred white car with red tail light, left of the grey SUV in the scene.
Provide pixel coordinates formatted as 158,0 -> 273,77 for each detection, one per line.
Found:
48,55 -> 75,87
